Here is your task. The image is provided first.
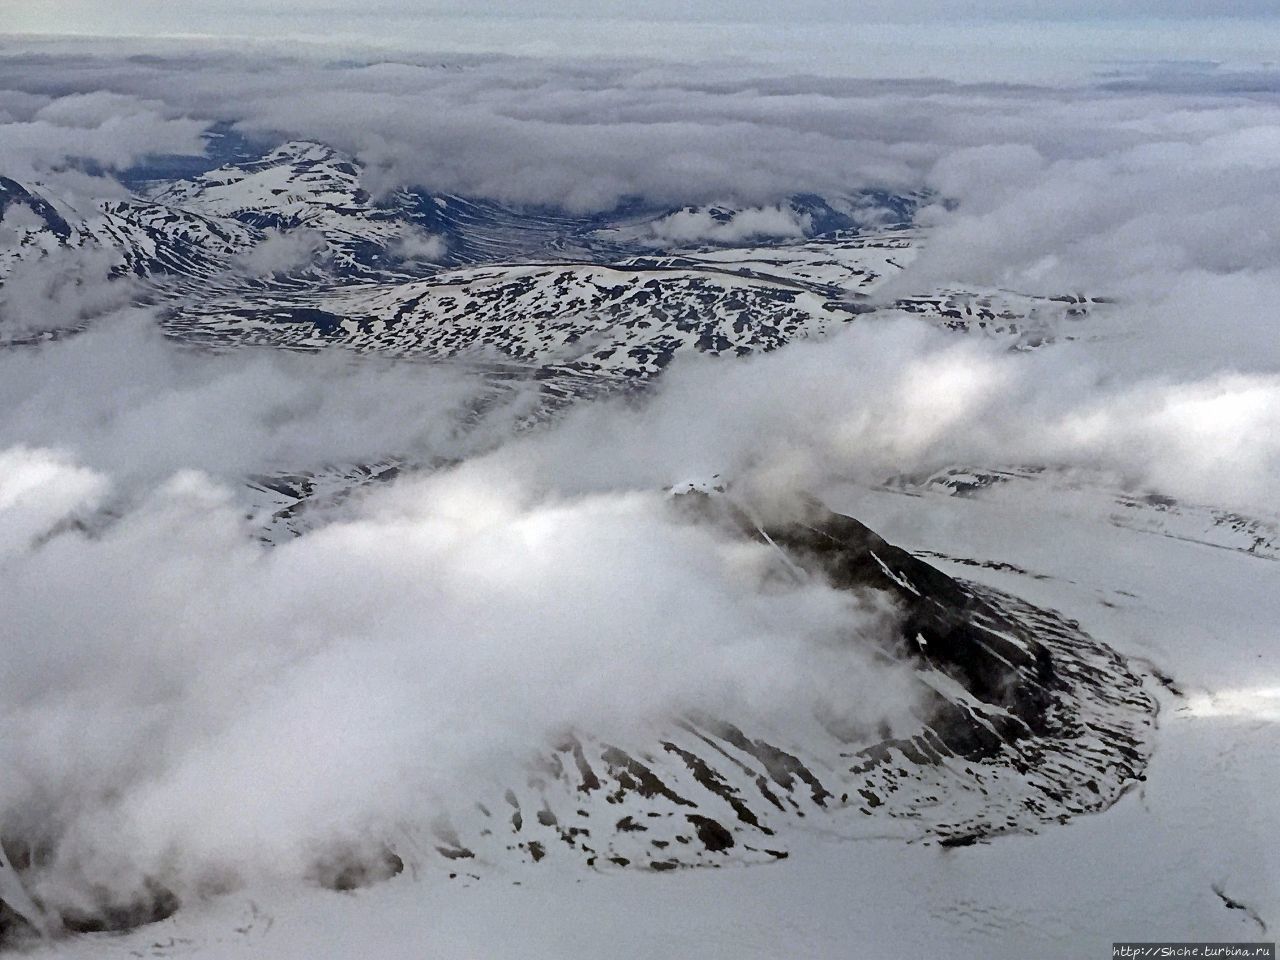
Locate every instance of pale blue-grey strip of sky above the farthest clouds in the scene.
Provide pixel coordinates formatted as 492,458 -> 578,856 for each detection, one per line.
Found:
0,0 -> 1280,79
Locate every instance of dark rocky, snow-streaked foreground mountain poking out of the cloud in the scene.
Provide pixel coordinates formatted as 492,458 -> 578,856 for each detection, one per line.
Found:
0,488 -> 1156,934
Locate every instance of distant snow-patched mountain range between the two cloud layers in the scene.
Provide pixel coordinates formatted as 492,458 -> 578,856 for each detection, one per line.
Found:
0,141 -> 1097,384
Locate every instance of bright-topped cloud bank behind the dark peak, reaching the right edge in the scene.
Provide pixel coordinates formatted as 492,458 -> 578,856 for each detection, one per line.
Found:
478,320 -> 1280,515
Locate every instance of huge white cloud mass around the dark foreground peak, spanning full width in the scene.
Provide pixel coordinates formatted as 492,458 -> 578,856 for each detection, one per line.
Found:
0,304 -> 1280,926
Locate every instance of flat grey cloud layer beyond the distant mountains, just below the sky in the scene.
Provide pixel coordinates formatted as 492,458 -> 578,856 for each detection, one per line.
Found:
0,41 -> 1275,229
